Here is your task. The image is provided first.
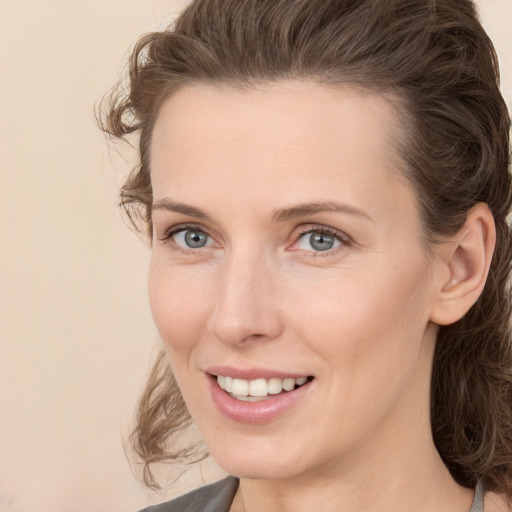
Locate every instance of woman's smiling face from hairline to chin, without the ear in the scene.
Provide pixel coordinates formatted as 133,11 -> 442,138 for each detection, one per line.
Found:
149,81 -> 444,478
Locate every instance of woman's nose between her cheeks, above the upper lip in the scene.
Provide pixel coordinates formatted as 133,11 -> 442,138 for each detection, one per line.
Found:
208,251 -> 283,345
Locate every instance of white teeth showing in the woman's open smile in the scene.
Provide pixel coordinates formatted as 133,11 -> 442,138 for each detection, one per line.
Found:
216,375 -> 313,402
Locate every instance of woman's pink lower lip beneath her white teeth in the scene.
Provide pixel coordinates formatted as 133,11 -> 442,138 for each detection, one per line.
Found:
209,376 -> 313,425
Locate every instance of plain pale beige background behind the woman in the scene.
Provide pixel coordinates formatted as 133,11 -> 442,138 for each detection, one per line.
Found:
0,0 -> 512,512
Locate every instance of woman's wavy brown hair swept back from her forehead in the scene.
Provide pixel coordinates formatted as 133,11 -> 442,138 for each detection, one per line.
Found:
98,0 -> 512,498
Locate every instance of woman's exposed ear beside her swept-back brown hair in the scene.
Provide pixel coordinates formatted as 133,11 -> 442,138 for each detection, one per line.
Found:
430,203 -> 496,325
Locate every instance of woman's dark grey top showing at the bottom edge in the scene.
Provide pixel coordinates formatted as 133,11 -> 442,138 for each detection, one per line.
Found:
140,476 -> 485,512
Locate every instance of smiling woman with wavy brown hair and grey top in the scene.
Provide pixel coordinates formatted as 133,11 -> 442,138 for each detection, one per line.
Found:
99,0 -> 512,512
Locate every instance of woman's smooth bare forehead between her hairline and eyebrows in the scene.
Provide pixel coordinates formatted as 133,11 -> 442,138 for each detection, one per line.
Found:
150,80 -> 411,224
